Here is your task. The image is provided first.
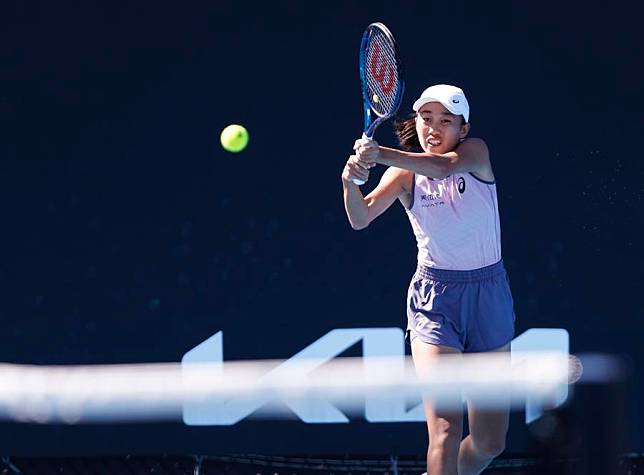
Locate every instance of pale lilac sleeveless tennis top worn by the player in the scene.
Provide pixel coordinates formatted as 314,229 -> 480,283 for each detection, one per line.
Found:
405,173 -> 501,270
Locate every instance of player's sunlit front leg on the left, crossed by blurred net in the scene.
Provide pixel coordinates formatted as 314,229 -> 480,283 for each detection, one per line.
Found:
411,338 -> 463,475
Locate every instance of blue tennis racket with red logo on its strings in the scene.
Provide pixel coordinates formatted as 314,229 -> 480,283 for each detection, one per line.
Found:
353,23 -> 405,185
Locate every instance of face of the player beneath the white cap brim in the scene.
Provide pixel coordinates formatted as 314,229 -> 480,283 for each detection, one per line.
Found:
416,102 -> 470,153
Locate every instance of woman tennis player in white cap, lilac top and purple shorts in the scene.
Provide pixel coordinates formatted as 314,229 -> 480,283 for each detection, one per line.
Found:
342,84 -> 514,475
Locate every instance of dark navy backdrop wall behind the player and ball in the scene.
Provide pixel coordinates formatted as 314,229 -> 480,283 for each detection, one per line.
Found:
0,1 -> 644,454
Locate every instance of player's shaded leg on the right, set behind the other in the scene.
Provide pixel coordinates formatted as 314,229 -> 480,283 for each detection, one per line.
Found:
458,344 -> 510,475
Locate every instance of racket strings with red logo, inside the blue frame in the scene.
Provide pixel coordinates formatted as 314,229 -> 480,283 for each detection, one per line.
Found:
365,30 -> 400,116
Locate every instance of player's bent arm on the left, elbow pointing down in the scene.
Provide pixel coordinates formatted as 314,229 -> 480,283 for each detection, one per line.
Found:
342,155 -> 411,230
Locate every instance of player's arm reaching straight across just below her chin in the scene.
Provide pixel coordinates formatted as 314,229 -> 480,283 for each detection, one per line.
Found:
356,138 -> 494,181
